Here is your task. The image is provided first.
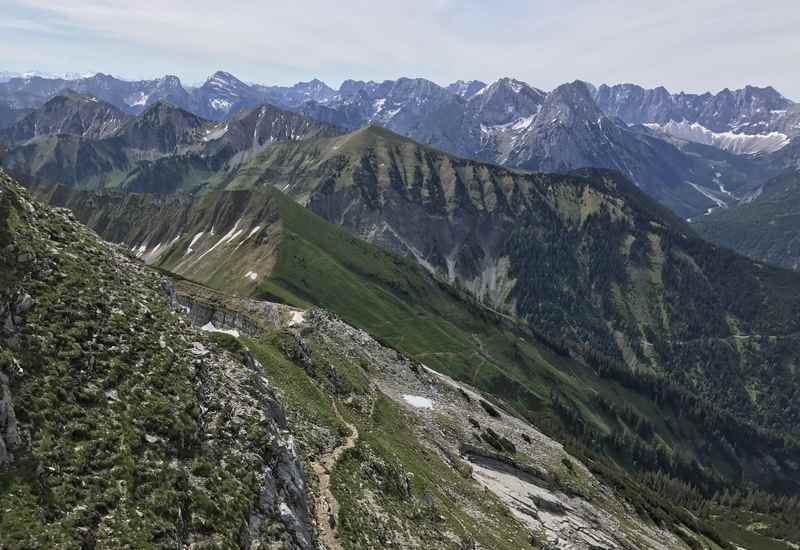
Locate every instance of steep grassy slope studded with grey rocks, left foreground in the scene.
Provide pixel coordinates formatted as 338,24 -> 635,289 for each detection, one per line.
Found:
0,174 -> 316,550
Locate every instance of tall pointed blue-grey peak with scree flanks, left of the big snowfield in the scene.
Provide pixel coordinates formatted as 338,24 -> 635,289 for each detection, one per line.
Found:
480,81 -> 759,217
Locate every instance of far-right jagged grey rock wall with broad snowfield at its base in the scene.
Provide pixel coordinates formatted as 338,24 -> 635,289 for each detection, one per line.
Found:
595,84 -> 800,154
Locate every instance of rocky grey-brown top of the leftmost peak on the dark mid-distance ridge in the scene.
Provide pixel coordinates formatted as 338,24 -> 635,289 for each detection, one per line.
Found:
0,92 -> 131,142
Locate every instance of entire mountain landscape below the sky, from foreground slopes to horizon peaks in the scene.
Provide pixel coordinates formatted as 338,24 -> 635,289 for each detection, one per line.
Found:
0,68 -> 800,550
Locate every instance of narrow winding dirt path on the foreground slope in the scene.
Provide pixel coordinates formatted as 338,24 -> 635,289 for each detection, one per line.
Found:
311,401 -> 358,550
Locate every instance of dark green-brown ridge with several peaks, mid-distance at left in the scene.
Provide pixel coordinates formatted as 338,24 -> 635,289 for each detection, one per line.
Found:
0,92 -> 342,192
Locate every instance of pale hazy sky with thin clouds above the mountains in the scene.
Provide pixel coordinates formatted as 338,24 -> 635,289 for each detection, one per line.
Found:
0,0 -> 800,100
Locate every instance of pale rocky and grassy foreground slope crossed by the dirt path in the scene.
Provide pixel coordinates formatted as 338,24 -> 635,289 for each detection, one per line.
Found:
166,282 -> 736,549
